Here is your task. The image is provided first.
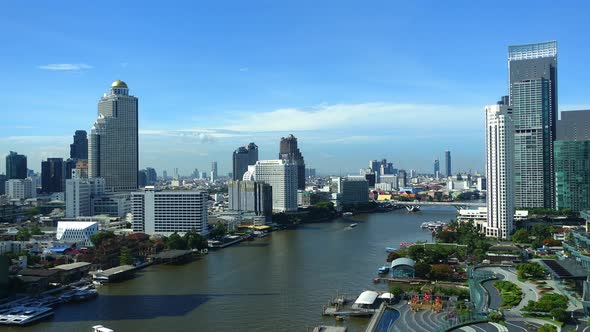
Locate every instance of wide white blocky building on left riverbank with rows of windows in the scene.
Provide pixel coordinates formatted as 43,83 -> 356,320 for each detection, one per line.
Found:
131,186 -> 209,236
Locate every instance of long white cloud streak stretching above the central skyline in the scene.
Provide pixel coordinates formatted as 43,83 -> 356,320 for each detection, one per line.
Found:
222,103 -> 484,132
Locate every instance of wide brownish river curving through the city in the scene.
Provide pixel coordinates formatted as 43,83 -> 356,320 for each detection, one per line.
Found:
12,207 -> 456,332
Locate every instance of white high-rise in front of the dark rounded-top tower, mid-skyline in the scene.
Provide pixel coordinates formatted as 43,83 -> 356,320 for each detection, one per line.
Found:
256,159 -> 298,212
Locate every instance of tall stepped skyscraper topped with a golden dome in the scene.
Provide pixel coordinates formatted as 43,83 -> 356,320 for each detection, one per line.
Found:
88,80 -> 139,191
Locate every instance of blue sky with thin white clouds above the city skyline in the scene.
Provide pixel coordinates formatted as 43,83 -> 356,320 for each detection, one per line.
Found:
0,1 -> 590,174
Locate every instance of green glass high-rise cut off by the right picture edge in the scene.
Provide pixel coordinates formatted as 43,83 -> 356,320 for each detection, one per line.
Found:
554,110 -> 590,212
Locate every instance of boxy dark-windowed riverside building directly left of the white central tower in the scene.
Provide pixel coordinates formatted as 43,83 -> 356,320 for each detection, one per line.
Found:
228,180 -> 272,217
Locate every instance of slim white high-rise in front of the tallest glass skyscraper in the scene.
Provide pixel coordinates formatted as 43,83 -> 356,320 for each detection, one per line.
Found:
485,105 -> 514,239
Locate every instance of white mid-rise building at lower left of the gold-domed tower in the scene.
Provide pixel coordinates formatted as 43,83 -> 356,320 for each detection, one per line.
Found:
66,177 -> 105,218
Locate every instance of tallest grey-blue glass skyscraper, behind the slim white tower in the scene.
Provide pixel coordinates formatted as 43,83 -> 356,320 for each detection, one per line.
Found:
508,41 -> 557,208
